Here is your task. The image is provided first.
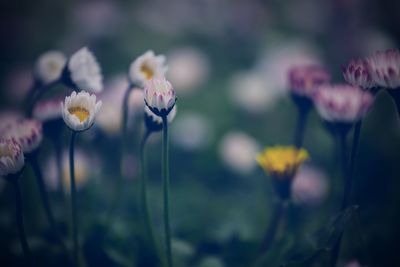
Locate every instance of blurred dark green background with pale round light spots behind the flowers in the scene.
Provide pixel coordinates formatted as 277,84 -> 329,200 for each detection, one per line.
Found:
0,0 -> 400,267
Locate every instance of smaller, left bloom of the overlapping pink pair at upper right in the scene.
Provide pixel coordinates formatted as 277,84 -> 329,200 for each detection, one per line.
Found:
343,59 -> 376,89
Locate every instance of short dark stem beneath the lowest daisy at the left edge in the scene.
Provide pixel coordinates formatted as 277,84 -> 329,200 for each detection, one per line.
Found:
11,179 -> 30,263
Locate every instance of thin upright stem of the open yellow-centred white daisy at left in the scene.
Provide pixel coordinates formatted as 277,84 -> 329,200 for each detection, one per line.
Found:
69,131 -> 79,266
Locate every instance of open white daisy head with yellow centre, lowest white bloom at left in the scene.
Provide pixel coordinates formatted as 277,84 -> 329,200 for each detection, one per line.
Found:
61,91 -> 101,131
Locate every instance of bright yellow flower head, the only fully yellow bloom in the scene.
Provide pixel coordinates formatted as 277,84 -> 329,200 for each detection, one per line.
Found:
257,146 -> 309,178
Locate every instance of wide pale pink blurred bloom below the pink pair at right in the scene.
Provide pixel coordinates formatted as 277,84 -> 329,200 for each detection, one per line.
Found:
313,84 -> 374,123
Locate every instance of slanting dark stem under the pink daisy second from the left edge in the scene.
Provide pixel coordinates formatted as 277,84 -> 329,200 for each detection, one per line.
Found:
29,152 -> 66,251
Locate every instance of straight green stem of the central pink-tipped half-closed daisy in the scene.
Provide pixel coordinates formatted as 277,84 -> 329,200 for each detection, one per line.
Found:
162,115 -> 173,267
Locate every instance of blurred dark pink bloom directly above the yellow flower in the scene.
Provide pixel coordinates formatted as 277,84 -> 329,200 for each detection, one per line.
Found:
289,65 -> 331,97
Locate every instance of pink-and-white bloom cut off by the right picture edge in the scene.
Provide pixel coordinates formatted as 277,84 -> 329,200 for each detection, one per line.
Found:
366,49 -> 400,89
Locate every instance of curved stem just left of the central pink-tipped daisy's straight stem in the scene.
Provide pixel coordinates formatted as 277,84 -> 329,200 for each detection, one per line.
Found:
140,130 -> 159,266
